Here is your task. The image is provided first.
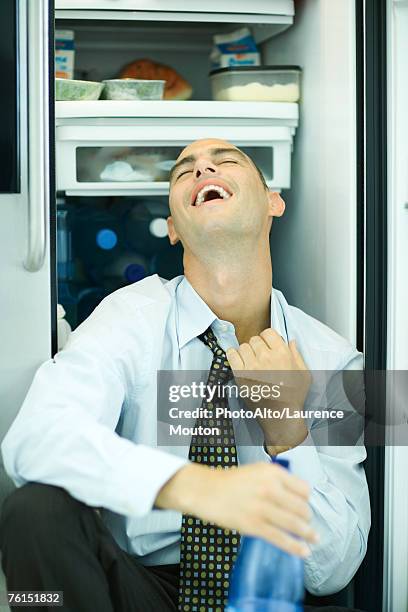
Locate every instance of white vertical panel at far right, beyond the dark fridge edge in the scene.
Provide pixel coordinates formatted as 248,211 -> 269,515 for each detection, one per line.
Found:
383,0 -> 408,612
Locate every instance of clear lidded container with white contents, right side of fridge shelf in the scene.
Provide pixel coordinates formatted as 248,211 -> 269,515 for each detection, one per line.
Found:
210,66 -> 301,102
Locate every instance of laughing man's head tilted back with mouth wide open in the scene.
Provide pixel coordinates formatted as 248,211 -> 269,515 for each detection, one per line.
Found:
168,138 -> 285,266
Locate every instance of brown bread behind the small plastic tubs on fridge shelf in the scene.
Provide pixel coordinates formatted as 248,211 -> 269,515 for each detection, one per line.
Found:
119,59 -> 193,100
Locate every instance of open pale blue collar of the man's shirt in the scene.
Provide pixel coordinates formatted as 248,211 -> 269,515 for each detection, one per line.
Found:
176,276 -> 288,349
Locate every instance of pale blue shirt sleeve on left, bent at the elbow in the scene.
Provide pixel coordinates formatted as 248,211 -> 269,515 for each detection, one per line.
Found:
1,301 -> 187,516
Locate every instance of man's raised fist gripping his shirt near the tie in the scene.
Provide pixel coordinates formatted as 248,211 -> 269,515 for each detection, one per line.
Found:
226,328 -> 311,455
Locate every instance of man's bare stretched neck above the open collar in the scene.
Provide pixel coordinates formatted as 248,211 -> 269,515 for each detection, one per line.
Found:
184,241 -> 272,344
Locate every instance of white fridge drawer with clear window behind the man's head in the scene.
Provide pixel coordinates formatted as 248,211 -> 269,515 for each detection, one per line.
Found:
56,125 -> 293,195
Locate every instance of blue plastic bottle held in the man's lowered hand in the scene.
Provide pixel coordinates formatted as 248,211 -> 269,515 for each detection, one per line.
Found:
226,459 -> 304,612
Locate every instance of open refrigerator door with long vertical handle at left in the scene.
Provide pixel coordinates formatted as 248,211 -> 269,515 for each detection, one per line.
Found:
0,0 -> 55,503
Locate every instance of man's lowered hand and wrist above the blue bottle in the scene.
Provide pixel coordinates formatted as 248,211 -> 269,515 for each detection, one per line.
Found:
155,463 -> 317,557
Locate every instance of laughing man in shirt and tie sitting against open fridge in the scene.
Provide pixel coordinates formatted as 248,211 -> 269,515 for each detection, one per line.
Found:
0,139 -> 370,612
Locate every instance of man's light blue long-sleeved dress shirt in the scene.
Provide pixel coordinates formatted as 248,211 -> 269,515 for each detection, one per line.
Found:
2,275 -> 370,594
